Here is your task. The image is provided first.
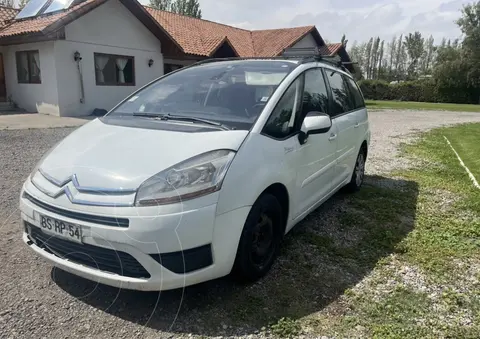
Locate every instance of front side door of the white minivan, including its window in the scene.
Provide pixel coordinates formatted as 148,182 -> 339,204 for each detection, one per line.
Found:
294,68 -> 337,218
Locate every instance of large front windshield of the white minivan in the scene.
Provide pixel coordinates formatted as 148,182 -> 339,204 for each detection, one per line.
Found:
108,60 -> 296,129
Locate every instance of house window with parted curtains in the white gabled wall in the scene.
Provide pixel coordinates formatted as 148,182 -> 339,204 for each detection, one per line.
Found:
93,53 -> 135,86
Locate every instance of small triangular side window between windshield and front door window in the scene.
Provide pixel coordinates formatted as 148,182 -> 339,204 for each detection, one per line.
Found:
264,77 -> 302,139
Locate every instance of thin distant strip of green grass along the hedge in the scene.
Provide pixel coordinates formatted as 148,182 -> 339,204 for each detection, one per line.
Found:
366,100 -> 480,112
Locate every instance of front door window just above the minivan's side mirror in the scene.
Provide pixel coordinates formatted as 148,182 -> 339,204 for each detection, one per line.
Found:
302,69 -> 328,116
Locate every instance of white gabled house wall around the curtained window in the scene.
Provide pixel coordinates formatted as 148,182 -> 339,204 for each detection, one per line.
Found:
54,0 -> 163,116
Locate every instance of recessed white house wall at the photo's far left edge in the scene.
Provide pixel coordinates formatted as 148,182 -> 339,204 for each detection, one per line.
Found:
1,41 -> 59,115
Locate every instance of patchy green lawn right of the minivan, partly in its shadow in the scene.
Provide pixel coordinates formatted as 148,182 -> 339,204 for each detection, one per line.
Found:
273,124 -> 480,338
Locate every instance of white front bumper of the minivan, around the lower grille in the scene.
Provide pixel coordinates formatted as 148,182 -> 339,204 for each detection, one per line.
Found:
20,188 -> 250,291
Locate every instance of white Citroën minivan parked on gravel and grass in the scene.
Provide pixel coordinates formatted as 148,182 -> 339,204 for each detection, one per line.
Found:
20,57 -> 370,290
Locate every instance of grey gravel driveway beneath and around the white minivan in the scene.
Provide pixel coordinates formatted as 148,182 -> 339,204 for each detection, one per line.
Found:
0,111 -> 480,338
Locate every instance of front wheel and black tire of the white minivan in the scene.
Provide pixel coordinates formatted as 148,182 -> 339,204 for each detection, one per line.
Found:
232,194 -> 284,282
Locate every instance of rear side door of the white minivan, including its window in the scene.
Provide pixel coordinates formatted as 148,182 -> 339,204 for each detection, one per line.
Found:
325,68 -> 358,186
